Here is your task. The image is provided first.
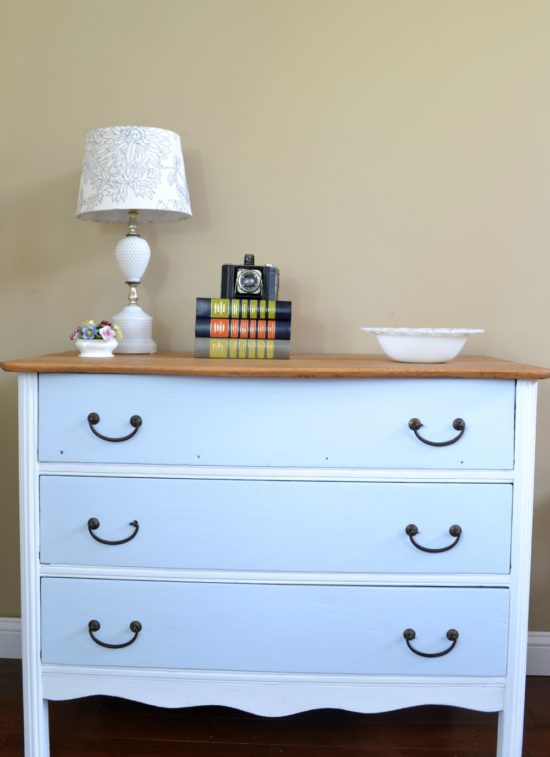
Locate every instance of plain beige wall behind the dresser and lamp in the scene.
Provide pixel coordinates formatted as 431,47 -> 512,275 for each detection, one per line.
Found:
0,0 -> 550,630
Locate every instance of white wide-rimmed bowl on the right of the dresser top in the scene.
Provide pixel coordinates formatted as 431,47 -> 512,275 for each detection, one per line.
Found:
361,326 -> 484,363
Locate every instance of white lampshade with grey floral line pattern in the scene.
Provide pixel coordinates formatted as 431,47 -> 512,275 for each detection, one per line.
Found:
76,126 -> 191,223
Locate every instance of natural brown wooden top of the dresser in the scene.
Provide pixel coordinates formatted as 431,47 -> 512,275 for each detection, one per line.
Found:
0,352 -> 550,380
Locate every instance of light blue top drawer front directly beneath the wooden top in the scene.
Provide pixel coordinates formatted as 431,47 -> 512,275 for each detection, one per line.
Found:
39,374 -> 515,469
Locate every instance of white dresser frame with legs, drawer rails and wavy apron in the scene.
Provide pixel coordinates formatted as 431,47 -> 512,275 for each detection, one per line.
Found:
19,373 -> 537,757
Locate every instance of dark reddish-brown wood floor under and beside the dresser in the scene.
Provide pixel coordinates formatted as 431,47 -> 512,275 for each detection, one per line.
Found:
0,660 -> 550,757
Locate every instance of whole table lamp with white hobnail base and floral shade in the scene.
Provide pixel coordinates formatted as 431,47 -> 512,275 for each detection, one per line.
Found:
76,126 -> 191,354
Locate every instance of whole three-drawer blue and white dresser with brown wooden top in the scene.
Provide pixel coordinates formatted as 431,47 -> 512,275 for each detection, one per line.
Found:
3,353 -> 550,757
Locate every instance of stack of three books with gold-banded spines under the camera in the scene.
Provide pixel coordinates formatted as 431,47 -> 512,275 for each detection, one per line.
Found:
194,297 -> 292,360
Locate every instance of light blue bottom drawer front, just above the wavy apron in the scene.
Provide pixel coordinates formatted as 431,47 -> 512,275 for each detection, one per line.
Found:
42,578 -> 508,676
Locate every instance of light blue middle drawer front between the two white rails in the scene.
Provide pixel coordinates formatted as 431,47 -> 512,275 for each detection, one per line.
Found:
40,476 -> 512,573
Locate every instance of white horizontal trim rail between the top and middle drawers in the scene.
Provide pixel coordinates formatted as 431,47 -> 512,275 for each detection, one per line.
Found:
38,463 -> 515,484
